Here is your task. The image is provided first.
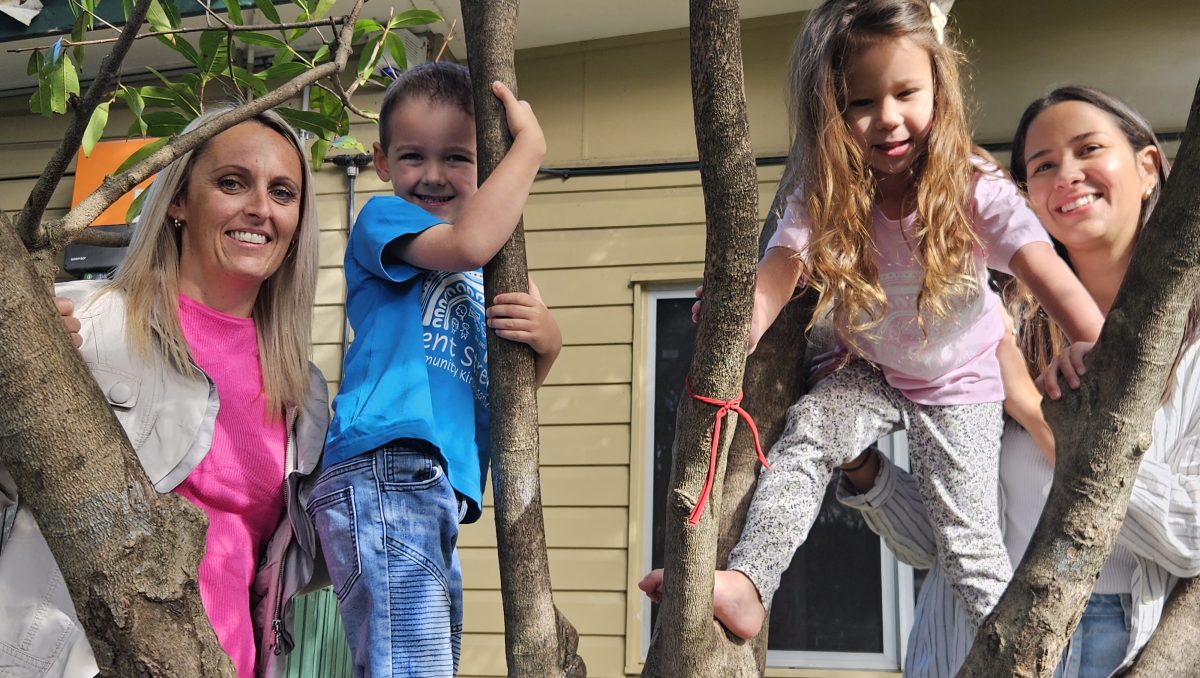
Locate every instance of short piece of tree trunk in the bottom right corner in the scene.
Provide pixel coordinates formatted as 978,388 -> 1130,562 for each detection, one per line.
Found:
1122,578 -> 1200,678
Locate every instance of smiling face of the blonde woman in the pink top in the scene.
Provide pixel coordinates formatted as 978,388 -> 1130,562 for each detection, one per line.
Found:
167,121 -> 304,309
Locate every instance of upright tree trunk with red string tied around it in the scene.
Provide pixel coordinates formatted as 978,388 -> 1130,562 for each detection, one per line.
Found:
642,0 -> 760,678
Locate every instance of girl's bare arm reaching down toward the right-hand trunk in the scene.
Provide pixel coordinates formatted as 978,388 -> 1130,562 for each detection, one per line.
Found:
1008,242 -> 1104,342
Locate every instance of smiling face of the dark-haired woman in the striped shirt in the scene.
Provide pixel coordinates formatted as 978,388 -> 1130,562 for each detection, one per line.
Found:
1025,101 -> 1159,253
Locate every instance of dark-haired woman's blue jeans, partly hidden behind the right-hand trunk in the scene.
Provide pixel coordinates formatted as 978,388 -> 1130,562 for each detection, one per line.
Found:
1055,593 -> 1133,678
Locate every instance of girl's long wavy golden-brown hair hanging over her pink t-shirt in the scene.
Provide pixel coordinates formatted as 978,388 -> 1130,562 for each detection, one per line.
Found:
784,0 -> 979,347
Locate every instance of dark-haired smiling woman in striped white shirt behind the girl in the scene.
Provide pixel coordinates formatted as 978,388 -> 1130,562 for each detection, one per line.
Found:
839,88 -> 1200,678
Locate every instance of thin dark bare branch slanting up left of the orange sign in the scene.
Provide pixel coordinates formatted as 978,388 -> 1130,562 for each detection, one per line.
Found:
16,0 -> 152,251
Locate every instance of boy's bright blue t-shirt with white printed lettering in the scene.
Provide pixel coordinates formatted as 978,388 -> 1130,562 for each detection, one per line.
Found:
325,196 -> 488,522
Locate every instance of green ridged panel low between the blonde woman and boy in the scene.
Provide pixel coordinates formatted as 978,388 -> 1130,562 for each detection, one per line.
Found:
286,587 -> 350,678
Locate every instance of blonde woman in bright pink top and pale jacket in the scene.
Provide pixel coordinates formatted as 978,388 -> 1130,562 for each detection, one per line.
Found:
0,109 -> 329,678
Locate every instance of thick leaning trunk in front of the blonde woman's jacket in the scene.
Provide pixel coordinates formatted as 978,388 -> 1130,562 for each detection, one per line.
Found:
0,214 -> 234,678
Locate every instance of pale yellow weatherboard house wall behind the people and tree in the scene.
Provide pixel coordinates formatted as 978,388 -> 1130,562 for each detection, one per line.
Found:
0,0 -> 1200,678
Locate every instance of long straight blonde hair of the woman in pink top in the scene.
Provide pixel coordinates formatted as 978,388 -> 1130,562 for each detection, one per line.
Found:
106,106 -> 318,416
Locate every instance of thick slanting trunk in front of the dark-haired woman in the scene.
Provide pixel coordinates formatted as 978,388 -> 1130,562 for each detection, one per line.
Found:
959,75 -> 1200,677
